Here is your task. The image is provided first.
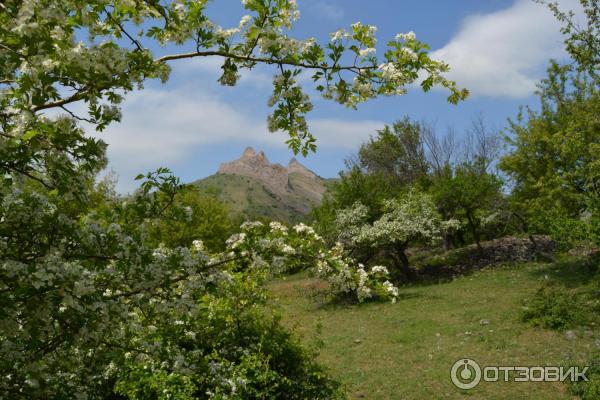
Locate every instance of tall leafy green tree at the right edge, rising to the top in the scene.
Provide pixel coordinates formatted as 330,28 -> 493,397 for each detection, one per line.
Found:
500,0 -> 600,242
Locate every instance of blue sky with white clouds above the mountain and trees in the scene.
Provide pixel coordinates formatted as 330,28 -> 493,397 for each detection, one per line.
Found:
100,0 -> 575,192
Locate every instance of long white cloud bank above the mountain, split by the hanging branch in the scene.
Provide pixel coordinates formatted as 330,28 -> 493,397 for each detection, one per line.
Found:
94,87 -> 383,190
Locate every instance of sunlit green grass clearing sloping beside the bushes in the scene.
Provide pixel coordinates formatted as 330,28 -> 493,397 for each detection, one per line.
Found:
270,263 -> 600,400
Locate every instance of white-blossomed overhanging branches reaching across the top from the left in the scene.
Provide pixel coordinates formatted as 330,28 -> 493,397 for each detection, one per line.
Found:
0,0 -> 468,153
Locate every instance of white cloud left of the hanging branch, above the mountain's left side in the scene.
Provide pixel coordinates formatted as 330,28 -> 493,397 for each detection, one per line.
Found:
96,89 -> 276,168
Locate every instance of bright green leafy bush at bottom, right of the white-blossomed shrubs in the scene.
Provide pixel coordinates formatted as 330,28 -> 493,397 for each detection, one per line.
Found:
114,274 -> 341,400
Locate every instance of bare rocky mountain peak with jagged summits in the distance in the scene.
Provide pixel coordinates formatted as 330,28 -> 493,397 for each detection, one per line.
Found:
194,147 -> 327,222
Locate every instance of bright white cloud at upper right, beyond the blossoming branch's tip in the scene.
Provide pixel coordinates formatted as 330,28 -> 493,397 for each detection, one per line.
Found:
432,0 -> 577,98
